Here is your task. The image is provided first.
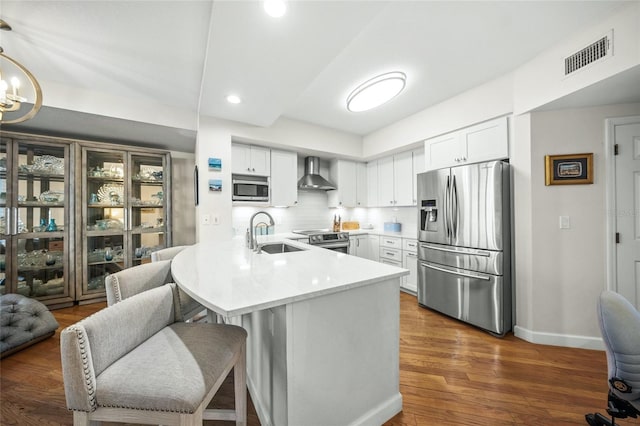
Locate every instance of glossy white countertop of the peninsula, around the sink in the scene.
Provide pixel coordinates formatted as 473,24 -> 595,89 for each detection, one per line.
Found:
171,238 -> 409,317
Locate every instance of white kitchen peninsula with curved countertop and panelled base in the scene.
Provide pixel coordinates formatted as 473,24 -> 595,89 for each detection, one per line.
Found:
172,235 -> 408,426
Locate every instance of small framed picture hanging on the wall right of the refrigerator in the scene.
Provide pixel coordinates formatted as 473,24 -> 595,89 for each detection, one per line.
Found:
544,153 -> 593,185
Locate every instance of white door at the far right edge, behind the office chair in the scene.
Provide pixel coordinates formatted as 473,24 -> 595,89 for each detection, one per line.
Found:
614,117 -> 640,308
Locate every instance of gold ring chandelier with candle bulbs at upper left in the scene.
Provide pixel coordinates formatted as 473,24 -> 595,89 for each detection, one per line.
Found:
0,19 -> 42,124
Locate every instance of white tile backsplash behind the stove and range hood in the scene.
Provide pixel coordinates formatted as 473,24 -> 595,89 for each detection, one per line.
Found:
232,191 -> 418,235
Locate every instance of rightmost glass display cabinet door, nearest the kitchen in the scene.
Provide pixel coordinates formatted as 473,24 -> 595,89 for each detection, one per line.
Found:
128,154 -> 167,266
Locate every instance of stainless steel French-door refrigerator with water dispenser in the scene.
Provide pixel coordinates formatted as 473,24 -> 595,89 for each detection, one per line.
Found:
418,161 -> 512,336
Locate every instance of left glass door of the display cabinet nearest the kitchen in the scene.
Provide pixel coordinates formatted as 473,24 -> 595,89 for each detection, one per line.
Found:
80,148 -> 128,298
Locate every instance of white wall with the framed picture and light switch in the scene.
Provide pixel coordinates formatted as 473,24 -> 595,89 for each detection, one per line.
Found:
515,104 -> 640,348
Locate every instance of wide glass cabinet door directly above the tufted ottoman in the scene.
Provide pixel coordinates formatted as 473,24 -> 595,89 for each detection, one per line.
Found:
10,140 -> 73,304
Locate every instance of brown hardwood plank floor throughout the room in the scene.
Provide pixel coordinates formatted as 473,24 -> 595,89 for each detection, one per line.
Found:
0,293 -> 638,426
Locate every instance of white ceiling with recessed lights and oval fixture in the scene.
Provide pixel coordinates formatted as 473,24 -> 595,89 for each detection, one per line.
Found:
0,0 -> 640,149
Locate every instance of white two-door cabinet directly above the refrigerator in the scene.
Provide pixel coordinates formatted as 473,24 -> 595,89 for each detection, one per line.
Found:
424,117 -> 509,170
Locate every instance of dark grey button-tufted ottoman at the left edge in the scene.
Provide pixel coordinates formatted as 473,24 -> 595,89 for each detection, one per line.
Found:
0,293 -> 58,358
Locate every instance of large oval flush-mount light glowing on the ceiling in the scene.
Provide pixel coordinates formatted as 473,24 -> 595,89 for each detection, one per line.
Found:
347,71 -> 407,112
